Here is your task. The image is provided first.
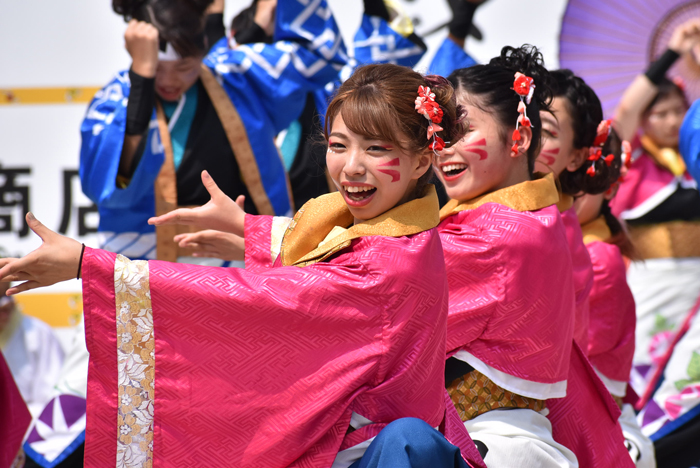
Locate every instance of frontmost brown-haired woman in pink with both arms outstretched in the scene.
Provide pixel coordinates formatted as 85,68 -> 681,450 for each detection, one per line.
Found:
0,65 -> 486,467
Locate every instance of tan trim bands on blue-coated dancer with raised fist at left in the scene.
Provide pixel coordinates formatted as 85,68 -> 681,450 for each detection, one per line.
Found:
155,64 -> 293,262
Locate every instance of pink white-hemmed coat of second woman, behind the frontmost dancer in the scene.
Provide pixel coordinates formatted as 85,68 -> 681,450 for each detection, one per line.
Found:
438,203 -> 574,400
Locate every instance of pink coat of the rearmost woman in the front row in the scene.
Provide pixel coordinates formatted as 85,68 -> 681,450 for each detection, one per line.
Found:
586,233 -> 637,397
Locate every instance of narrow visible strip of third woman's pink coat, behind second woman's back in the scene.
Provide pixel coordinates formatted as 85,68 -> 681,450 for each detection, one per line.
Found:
561,206 -> 593,350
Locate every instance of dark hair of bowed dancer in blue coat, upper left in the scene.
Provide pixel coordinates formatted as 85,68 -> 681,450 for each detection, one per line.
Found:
112,0 -> 213,57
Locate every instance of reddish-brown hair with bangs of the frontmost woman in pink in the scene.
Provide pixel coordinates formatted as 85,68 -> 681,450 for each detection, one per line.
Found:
324,64 -> 465,186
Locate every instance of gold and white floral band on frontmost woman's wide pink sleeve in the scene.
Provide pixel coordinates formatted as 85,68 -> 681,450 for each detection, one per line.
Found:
114,255 -> 155,468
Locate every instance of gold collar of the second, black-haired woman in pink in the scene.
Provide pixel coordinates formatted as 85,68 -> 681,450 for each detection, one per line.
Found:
440,173 -> 559,220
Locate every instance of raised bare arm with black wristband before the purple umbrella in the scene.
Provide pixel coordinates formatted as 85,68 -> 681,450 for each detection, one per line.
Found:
615,19 -> 700,140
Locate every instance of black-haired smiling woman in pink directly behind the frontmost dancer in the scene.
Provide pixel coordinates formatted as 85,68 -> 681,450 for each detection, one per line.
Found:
436,47 -> 578,468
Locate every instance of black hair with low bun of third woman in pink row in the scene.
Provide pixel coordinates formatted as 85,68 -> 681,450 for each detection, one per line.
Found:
551,70 -> 622,196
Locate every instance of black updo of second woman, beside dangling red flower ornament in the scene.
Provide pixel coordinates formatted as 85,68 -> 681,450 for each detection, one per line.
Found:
448,44 -> 552,172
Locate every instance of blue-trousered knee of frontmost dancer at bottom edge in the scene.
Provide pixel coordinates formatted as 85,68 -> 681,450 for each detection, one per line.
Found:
350,418 -> 469,468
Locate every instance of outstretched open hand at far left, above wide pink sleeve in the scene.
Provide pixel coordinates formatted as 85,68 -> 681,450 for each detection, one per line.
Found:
0,213 -> 82,296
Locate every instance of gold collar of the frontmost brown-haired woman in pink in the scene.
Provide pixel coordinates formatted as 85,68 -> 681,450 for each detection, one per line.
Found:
281,185 -> 440,266
